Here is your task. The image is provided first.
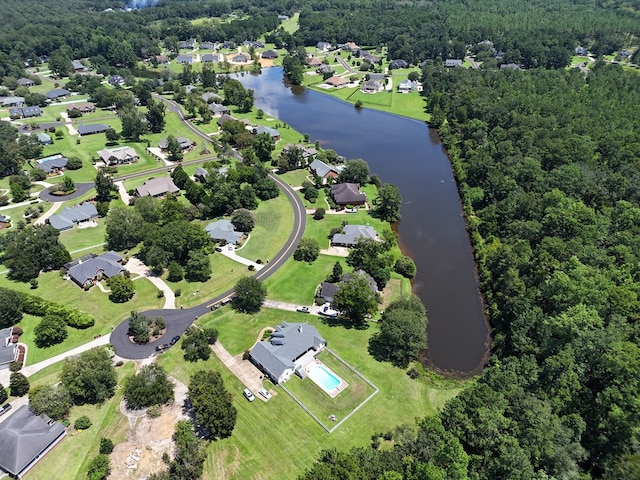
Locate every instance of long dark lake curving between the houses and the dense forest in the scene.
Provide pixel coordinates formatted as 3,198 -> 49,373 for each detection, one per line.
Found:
237,68 -> 489,375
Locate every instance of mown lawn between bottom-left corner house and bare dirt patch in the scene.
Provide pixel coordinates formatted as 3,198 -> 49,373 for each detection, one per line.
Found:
24,363 -> 135,480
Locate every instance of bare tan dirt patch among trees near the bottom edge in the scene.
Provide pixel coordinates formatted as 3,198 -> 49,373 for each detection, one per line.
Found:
109,380 -> 187,480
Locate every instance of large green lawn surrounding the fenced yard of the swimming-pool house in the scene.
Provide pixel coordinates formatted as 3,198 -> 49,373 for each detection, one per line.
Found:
158,308 -> 464,479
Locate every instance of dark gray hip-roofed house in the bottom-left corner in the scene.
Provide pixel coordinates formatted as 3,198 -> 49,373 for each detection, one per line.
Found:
0,405 -> 67,478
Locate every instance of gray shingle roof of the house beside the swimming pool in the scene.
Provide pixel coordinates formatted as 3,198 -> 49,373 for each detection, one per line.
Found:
250,322 -> 326,381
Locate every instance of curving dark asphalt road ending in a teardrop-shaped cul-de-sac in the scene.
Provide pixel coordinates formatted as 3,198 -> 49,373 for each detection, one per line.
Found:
111,99 -> 306,359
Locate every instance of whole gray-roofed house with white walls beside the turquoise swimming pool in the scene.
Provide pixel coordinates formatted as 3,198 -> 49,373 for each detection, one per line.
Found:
249,322 -> 327,385
